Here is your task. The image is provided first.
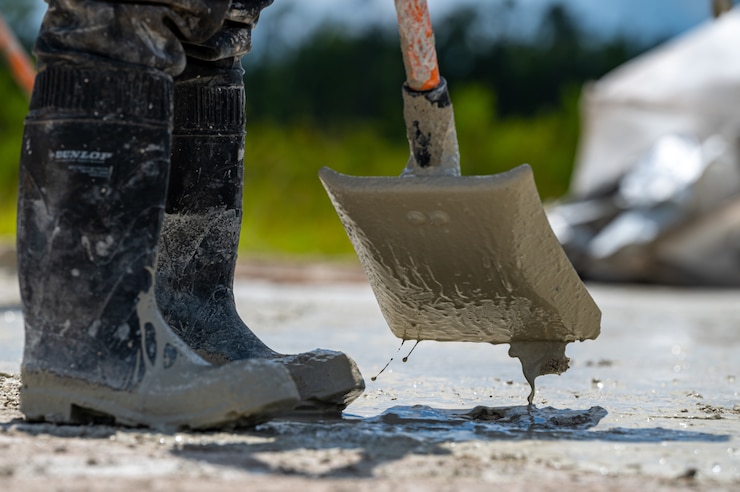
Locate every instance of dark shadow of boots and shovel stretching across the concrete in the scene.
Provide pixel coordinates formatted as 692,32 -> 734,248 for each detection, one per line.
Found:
0,405 -> 730,478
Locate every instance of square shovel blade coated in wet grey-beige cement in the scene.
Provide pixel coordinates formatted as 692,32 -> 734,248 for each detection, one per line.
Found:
319,165 -> 601,344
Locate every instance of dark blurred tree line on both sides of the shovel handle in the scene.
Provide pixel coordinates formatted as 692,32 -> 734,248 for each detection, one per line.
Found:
245,1 -> 647,125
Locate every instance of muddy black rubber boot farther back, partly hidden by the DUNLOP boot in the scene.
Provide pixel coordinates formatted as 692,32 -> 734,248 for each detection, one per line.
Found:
156,59 -> 365,411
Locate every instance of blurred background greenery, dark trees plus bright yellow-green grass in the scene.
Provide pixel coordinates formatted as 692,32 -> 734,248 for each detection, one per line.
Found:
0,2 -> 646,256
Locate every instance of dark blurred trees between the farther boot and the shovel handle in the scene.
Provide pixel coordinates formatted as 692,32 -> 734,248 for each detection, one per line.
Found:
245,25 -> 404,138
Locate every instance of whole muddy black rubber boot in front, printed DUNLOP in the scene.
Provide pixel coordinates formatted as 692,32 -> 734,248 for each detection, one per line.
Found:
18,57 -> 298,429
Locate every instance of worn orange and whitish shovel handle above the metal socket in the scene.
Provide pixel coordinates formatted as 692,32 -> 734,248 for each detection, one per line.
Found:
395,0 -> 441,91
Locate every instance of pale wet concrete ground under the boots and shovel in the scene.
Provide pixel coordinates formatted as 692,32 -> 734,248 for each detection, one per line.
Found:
0,265 -> 740,492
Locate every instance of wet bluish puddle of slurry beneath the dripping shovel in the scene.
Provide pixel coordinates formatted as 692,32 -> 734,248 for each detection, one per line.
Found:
258,405 -> 731,446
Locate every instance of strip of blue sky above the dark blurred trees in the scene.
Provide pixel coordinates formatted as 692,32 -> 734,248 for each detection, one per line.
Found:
236,0 -> 728,60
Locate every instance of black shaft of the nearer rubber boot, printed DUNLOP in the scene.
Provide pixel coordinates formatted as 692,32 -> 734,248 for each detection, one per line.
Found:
18,59 -> 172,386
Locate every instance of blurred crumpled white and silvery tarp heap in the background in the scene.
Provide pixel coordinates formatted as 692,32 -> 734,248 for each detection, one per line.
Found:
548,8 -> 740,286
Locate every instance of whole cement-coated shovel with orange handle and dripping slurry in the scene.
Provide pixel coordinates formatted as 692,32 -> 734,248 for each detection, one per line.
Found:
319,0 -> 601,404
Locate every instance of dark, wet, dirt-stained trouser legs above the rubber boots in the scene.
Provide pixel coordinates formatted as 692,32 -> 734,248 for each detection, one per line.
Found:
35,0 -> 273,76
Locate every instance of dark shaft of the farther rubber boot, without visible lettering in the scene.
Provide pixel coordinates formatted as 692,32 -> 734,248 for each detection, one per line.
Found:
158,60 -> 245,296
